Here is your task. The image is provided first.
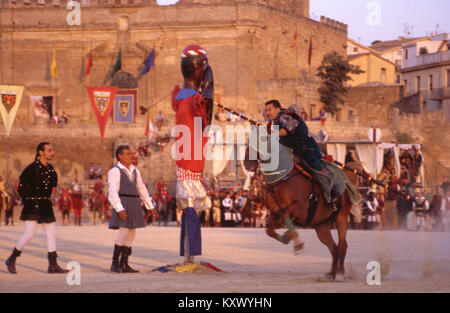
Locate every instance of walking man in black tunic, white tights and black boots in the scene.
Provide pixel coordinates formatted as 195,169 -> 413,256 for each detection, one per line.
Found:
5,142 -> 68,274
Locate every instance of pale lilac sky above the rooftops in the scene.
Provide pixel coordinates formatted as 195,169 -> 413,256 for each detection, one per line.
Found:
157,0 -> 450,45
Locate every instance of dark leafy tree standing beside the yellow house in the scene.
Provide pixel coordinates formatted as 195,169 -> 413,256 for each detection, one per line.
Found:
316,51 -> 364,113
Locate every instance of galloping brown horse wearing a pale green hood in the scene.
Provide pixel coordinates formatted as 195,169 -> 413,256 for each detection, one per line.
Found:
244,125 -> 360,282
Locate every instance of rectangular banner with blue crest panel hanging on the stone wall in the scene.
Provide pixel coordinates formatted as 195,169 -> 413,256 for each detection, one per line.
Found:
113,89 -> 137,123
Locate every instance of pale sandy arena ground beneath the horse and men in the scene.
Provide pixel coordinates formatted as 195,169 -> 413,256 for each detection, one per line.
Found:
0,223 -> 450,293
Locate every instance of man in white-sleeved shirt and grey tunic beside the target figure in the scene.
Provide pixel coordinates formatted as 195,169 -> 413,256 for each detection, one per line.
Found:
108,146 -> 158,273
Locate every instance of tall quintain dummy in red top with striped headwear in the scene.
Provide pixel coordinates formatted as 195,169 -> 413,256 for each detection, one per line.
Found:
172,45 -> 214,262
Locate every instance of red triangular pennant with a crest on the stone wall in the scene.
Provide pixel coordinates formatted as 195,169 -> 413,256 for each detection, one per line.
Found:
87,86 -> 117,139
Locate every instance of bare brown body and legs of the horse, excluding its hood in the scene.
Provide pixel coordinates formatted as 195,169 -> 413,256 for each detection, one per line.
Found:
244,148 -> 360,281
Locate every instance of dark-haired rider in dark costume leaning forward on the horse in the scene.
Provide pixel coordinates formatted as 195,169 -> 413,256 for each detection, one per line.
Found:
265,100 -> 341,206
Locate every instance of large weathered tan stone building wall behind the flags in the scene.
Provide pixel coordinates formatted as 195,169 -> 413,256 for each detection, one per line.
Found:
0,0 -> 347,188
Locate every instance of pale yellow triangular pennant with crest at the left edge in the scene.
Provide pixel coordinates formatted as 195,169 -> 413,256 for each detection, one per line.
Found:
0,85 -> 25,137
